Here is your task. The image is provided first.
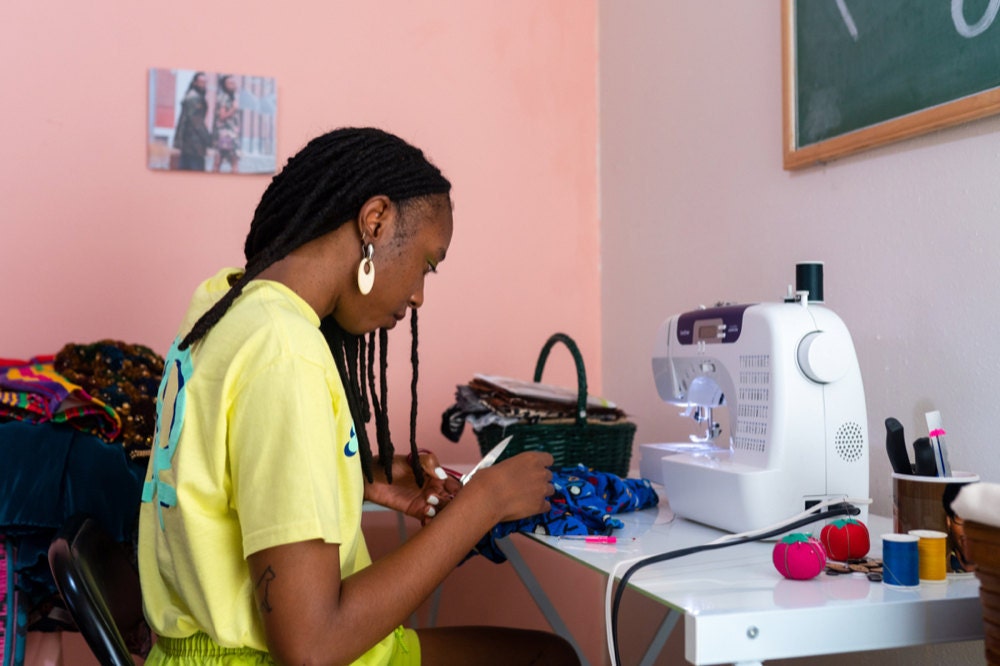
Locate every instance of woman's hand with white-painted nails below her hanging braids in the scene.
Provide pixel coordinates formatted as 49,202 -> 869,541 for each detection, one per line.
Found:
365,451 -> 462,524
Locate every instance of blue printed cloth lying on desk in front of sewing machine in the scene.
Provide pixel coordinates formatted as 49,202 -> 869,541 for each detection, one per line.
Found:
470,465 -> 660,563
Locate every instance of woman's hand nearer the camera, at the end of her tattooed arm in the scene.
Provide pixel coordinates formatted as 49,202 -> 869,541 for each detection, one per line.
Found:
463,451 -> 555,523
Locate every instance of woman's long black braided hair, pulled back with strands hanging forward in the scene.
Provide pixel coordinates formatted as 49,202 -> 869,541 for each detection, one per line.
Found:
179,128 -> 451,485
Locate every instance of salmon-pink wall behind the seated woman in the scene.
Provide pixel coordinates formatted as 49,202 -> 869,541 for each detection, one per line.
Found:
0,0 -> 616,659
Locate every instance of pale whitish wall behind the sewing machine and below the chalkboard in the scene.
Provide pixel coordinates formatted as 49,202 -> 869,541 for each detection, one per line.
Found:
599,1 -> 1000,664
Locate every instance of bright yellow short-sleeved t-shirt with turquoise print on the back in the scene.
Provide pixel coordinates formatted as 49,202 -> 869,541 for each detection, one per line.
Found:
139,269 -> 402,663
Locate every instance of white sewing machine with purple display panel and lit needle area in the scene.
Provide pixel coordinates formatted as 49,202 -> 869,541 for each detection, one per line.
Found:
640,294 -> 868,533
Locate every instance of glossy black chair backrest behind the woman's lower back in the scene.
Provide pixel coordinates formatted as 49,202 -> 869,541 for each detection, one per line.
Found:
48,515 -> 150,666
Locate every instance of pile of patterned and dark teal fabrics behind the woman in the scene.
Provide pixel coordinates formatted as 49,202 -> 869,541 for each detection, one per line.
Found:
0,340 -> 163,666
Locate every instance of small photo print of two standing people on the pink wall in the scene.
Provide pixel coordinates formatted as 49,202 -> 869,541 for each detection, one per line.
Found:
147,69 -> 278,174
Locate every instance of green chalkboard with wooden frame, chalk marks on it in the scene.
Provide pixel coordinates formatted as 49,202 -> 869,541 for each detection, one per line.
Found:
782,0 -> 1000,169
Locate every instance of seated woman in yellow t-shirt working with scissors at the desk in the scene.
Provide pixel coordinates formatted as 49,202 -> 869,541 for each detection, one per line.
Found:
139,129 -> 577,666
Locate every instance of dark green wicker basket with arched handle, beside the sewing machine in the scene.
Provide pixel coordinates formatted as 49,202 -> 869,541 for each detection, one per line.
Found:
476,333 -> 635,477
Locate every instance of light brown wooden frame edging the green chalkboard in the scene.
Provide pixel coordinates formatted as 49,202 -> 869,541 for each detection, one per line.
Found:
781,0 -> 1000,170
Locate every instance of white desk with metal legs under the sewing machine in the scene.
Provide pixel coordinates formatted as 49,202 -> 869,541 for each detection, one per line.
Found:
501,503 -> 983,664
